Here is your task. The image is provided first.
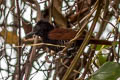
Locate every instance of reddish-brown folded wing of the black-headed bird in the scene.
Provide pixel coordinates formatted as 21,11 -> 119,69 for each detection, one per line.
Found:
48,28 -> 85,40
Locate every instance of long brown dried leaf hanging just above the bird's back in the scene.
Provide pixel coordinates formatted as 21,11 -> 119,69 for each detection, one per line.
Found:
52,0 -> 67,28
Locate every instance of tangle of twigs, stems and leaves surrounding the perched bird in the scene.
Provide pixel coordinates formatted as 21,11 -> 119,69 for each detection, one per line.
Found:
0,0 -> 120,80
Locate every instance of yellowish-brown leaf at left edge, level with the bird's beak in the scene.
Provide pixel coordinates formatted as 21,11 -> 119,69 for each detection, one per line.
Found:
0,29 -> 19,45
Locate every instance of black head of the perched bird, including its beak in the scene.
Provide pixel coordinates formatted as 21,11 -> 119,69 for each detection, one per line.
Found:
27,20 -> 54,39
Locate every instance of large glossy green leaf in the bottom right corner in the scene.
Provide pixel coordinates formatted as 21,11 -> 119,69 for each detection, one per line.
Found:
89,62 -> 120,80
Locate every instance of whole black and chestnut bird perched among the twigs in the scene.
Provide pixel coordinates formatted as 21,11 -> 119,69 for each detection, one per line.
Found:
26,20 -> 112,52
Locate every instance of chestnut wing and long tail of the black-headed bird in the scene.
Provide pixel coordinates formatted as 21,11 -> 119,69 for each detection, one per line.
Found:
48,28 -> 112,45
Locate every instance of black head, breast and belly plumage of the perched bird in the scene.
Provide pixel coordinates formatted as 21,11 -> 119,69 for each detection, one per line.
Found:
26,20 -> 68,52
